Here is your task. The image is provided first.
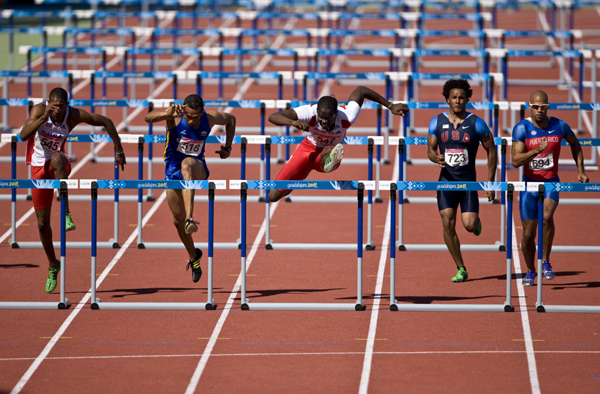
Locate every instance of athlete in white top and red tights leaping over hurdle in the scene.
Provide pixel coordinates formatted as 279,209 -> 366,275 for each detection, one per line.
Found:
268,86 -> 408,202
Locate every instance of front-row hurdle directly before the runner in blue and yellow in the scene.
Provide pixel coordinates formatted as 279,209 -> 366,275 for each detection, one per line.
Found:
80,179 -> 218,310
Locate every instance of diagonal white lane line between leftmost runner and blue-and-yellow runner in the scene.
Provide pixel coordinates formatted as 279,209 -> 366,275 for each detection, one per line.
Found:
10,192 -> 167,394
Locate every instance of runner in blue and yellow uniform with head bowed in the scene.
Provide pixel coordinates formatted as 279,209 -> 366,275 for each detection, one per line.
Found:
145,94 -> 235,282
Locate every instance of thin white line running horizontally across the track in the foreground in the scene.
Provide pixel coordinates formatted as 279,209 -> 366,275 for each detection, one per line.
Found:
0,350 -> 600,362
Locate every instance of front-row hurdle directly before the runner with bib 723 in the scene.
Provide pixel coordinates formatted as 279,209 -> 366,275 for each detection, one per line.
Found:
380,181 -> 514,312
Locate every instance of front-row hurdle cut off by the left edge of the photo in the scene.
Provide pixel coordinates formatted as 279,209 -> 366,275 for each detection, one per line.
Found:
0,180 -> 72,309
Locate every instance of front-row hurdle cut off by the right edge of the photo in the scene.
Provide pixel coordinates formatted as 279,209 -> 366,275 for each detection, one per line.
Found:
515,182 -> 600,313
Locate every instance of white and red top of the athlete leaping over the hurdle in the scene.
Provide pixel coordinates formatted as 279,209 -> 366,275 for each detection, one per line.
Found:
294,101 -> 360,148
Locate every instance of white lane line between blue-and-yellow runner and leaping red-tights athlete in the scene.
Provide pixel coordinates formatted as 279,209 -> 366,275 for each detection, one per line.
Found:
185,202 -> 279,394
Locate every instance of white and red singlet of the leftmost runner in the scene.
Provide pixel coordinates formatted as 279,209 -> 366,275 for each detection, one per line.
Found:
26,103 -> 71,166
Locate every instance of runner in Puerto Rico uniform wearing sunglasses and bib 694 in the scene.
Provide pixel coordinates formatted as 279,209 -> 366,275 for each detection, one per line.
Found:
511,90 -> 590,286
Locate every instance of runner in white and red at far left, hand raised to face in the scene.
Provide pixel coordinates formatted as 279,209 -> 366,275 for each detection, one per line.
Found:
20,88 -> 126,293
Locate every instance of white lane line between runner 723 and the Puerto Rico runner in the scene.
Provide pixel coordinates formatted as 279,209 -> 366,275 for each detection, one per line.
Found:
512,218 -> 541,394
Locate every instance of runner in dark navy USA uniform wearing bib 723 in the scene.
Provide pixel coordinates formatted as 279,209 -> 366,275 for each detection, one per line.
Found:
427,79 -> 497,282
